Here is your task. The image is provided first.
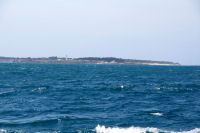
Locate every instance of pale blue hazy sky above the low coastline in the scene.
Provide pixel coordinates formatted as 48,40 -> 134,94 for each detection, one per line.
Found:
0,0 -> 200,65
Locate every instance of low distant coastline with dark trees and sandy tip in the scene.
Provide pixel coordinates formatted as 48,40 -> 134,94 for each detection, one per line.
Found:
0,56 -> 180,66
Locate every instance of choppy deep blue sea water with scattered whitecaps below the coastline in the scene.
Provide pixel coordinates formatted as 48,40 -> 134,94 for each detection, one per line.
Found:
0,63 -> 200,133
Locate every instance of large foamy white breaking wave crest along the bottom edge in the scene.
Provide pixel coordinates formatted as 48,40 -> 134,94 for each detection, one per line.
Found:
95,125 -> 200,133
